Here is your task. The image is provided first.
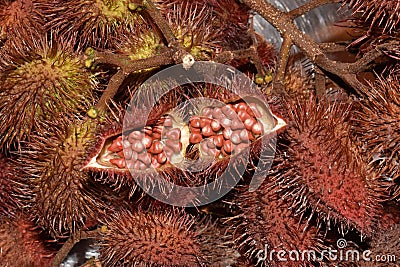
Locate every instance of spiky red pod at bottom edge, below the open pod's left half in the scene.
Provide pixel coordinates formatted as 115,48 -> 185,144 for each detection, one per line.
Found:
99,206 -> 239,267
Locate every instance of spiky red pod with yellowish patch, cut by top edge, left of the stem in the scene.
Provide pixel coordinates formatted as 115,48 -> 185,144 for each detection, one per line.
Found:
42,0 -> 147,50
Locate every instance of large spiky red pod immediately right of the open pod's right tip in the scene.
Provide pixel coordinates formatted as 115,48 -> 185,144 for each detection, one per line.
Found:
271,98 -> 378,238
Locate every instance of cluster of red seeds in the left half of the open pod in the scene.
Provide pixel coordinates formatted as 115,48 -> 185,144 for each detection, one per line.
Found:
108,116 -> 182,170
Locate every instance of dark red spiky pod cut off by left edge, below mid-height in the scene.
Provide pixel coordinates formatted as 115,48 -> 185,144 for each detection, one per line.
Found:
0,155 -> 31,217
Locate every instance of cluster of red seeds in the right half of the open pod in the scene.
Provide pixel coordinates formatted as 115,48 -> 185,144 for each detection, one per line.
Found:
189,101 -> 264,157
